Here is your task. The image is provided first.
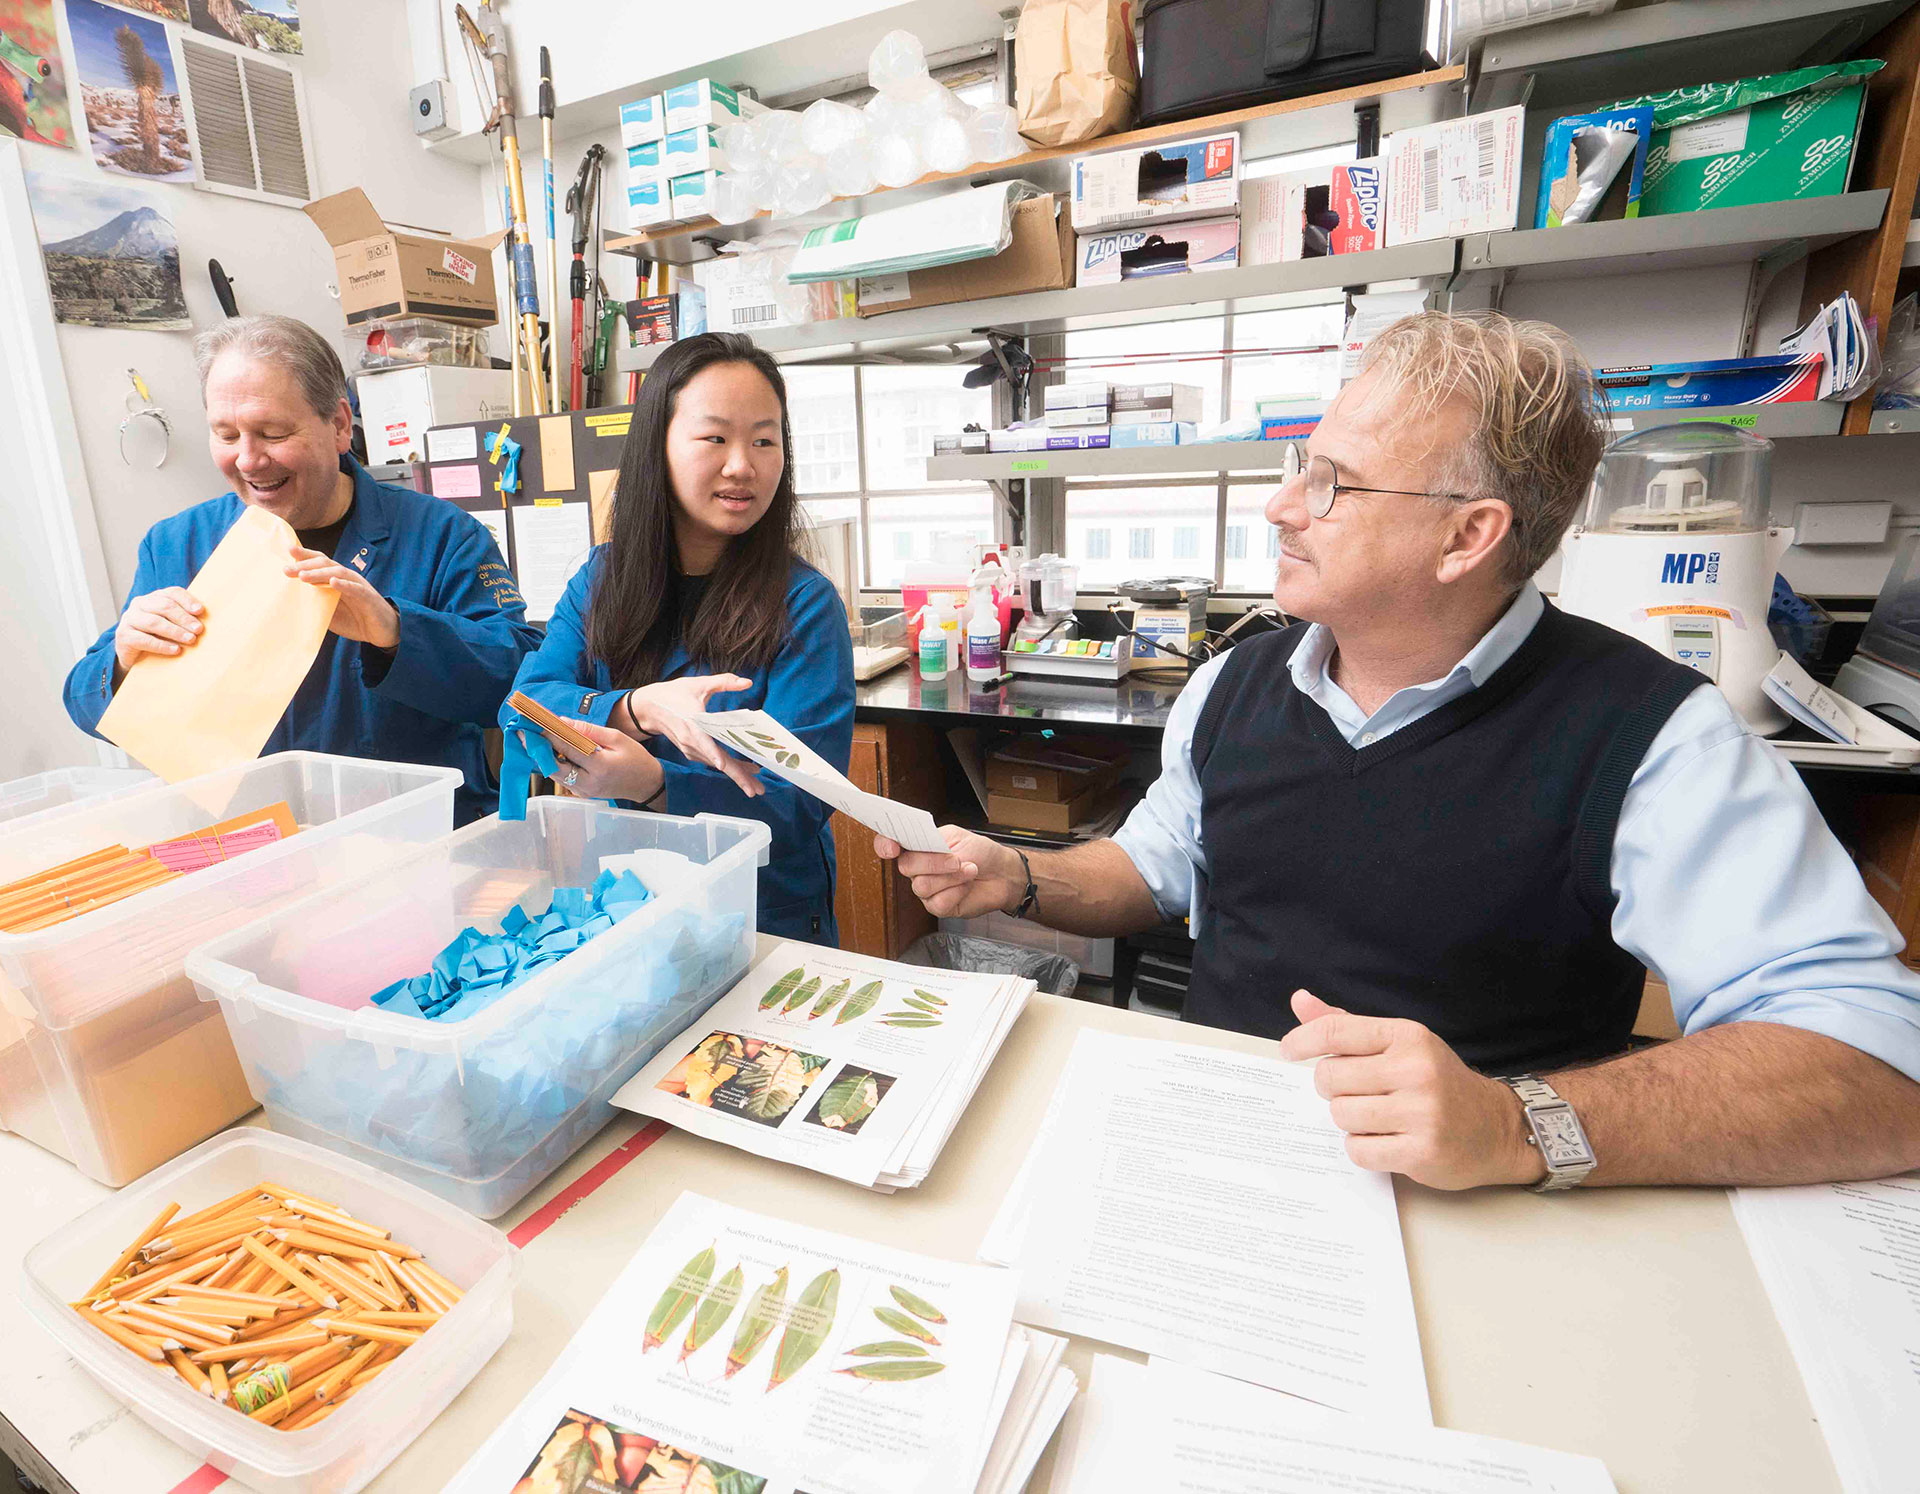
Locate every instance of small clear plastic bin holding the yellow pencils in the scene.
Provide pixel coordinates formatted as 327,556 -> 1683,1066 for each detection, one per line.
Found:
21,1127 -> 518,1494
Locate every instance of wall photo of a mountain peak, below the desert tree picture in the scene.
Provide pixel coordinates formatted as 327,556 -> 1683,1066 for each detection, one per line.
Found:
27,171 -> 192,332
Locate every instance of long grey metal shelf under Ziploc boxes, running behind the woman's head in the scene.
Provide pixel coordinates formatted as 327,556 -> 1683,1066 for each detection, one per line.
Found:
618,238 -> 1455,373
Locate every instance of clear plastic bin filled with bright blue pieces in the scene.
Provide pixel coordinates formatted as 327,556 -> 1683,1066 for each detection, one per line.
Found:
186,797 -> 772,1219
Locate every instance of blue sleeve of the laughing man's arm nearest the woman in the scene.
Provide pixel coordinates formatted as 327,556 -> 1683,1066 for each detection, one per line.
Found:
357,524 -> 540,726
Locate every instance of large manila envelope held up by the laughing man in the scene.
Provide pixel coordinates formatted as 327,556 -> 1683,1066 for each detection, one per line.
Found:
100,507 -> 340,783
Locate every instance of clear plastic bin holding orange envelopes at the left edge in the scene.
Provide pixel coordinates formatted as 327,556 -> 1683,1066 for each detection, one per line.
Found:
0,753 -> 461,1187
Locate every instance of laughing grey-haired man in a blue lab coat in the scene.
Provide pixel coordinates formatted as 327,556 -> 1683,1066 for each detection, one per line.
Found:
67,317 -> 540,824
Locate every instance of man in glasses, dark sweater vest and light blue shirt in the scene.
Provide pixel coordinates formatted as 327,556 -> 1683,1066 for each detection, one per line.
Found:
879,313 -> 1920,1189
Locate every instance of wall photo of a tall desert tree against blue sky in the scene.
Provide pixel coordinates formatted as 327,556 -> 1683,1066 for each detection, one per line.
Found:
67,0 -> 194,182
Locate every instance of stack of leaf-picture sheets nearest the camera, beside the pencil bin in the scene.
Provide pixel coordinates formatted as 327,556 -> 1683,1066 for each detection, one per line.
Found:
447,1193 -> 1075,1494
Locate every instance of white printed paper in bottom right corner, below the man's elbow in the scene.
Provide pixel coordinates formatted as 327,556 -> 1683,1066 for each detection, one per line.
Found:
1732,1173 -> 1920,1494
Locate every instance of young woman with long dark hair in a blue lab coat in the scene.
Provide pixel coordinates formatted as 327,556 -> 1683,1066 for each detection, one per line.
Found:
501,332 -> 852,945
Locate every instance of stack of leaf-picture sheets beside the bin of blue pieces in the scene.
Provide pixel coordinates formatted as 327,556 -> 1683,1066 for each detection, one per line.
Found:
612,943 -> 1033,1191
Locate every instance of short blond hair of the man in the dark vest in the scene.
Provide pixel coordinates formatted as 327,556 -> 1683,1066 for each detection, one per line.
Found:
1361,311 -> 1607,588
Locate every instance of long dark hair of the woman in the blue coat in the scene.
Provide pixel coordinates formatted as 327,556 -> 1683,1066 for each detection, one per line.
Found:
588,332 -> 803,687
